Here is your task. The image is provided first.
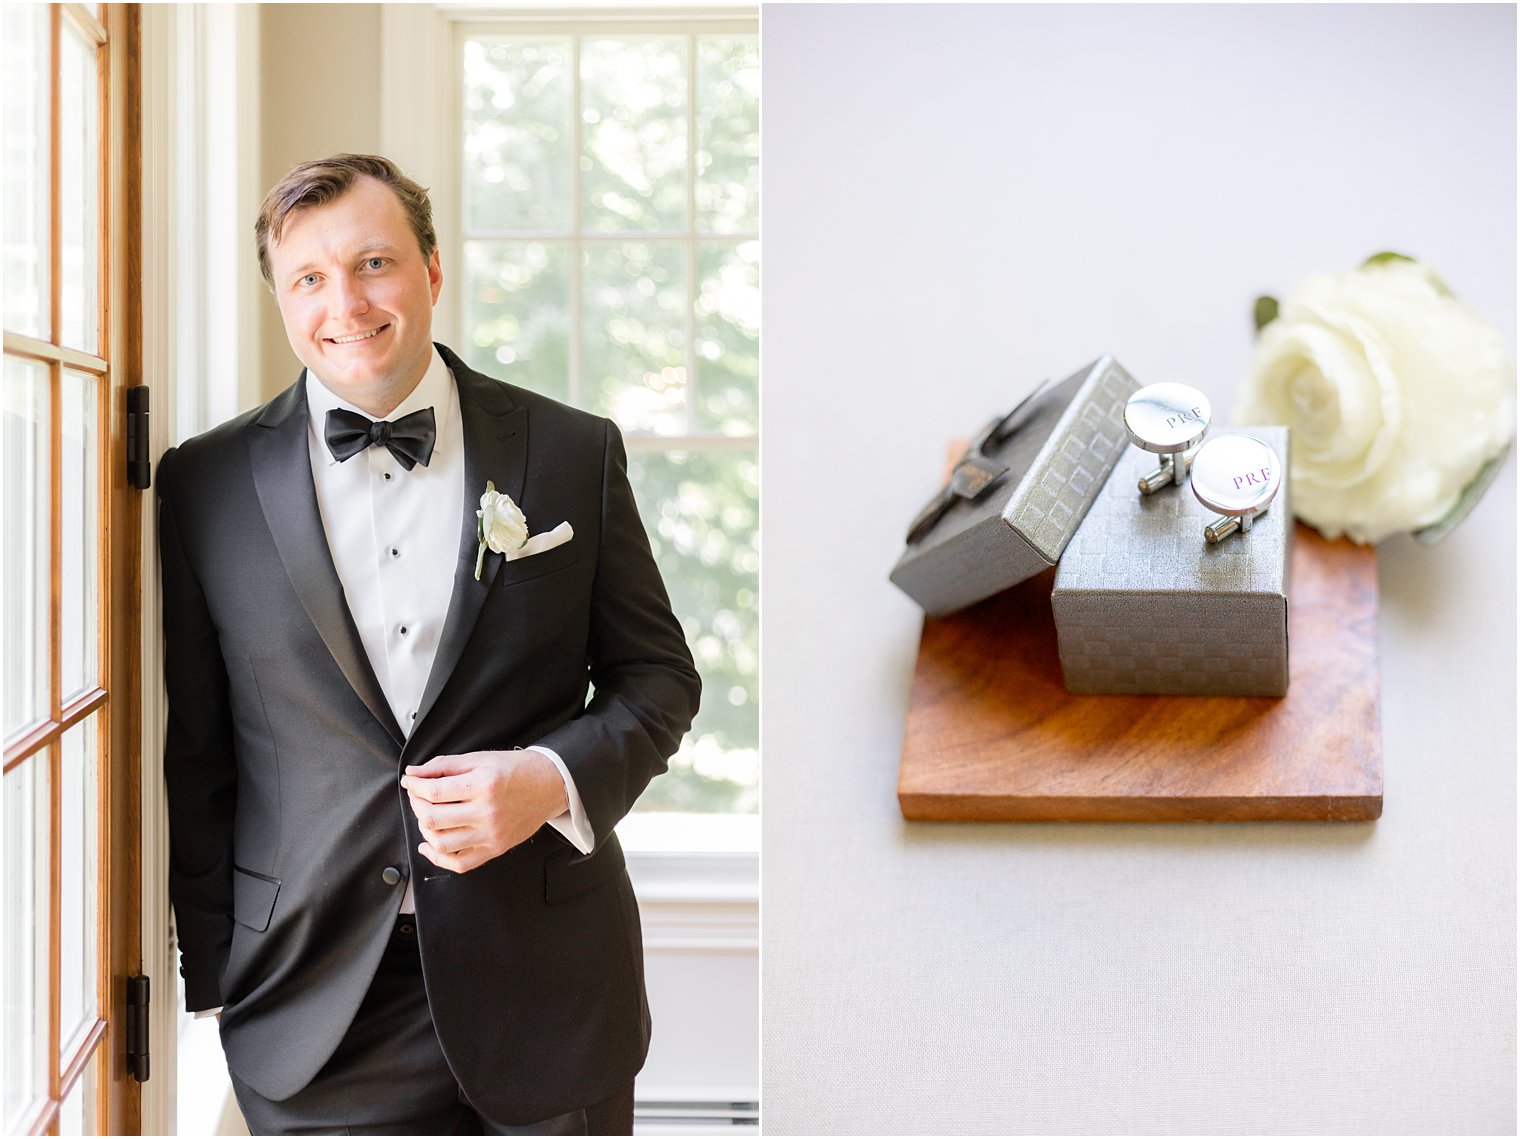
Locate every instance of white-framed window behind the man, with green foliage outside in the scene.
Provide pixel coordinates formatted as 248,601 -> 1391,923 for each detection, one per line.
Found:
454,20 -> 760,833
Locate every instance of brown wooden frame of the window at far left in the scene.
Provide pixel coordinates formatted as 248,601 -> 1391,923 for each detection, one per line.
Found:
3,3 -> 141,1134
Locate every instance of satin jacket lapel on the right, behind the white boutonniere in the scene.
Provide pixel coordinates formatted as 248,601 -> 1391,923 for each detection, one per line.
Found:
412,355 -> 527,729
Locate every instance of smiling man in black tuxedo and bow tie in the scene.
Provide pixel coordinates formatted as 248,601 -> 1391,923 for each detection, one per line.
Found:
158,155 -> 699,1134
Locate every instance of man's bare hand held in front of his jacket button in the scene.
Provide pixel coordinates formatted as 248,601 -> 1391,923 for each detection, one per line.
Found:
401,751 -> 568,874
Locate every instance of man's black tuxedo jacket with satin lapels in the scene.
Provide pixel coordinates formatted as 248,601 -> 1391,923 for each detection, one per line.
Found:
158,345 -> 699,1124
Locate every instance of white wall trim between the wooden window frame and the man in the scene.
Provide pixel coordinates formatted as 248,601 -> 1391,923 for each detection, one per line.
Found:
140,5 -> 261,1134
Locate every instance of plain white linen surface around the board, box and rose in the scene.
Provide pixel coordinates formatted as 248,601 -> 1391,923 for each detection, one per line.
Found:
762,5 -> 1515,1134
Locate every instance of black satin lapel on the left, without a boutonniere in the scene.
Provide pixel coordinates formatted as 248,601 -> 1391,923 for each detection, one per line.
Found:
248,382 -> 404,745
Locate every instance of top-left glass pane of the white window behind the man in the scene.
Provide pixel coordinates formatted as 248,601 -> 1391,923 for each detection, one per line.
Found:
464,36 -> 575,233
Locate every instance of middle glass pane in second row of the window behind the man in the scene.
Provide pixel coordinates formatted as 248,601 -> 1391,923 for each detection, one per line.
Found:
581,242 -> 687,435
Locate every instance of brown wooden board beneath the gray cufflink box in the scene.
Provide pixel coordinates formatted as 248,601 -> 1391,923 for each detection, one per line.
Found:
897,526 -> 1383,823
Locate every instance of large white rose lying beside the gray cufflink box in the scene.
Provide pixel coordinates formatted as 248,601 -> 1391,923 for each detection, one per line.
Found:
1236,254 -> 1515,543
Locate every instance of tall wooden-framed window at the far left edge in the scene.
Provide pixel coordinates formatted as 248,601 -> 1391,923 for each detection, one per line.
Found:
0,5 -> 140,1134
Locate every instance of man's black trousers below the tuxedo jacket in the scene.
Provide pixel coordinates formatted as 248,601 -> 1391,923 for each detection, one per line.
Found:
231,914 -> 634,1134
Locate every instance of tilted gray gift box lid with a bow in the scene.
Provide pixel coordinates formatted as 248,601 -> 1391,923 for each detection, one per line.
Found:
892,356 -> 1138,616
